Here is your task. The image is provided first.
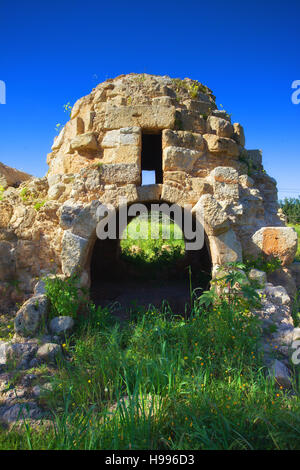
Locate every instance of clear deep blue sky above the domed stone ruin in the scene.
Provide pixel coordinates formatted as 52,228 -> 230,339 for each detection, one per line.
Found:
0,0 -> 300,197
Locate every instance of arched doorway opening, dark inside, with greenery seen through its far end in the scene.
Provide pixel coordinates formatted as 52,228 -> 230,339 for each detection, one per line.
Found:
90,201 -> 212,317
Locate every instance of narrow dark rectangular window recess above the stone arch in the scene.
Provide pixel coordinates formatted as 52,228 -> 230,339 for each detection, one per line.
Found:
142,132 -> 163,184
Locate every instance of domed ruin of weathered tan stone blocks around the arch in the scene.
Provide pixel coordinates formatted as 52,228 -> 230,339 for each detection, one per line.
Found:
0,74 -> 297,306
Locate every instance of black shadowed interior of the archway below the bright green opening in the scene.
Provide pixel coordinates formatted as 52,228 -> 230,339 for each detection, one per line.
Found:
91,213 -> 211,320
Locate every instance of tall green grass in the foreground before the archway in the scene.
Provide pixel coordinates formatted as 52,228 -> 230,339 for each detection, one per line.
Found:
0,288 -> 300,450
